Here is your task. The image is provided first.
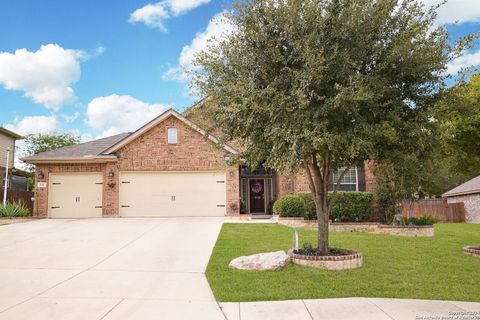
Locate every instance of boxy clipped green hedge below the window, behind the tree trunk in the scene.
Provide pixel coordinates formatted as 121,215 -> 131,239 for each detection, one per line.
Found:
298,192 -> 373,222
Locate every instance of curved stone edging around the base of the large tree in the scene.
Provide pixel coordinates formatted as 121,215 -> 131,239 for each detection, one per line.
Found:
292,252 -> 363,271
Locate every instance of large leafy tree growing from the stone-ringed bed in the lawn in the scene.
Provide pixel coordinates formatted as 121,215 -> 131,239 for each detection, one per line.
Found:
193,0 -> 467,254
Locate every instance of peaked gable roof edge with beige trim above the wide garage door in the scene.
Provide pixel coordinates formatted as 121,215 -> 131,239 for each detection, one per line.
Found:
105,109 -> 238,154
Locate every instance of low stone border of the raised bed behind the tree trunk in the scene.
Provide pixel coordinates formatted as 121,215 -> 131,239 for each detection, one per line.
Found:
277,217 -> 435,237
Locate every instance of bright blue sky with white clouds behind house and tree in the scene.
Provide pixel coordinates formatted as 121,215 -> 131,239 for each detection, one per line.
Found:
0,0 -> 480,165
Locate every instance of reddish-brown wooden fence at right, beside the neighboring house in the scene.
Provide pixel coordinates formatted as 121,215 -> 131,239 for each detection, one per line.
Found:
402,199 -> 465,222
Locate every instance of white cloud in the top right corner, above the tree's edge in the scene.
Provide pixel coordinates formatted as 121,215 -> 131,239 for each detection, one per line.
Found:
422,0 -> 480,24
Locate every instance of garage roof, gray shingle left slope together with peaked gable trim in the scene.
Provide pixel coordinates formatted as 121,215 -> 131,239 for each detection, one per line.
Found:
21,109 -> 238,164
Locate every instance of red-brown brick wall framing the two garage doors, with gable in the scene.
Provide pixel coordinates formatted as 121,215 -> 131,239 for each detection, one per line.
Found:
34,116 -> 240,217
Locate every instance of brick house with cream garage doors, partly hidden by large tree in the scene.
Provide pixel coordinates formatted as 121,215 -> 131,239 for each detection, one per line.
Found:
22,109 -> 373,218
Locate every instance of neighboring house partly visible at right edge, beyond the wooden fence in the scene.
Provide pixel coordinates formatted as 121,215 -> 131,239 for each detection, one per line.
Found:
442,176 -> 480,223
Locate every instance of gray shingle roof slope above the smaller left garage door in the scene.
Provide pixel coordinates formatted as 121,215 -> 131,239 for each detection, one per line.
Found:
22,133 -> 130,162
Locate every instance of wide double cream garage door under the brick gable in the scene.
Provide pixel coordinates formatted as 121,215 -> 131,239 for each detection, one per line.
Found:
120,171 -> 226,217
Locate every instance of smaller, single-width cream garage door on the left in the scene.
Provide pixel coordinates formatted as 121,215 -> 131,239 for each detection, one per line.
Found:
48,173 -> 103,218
